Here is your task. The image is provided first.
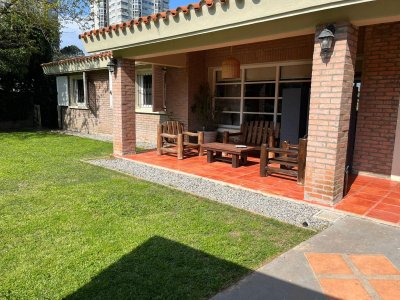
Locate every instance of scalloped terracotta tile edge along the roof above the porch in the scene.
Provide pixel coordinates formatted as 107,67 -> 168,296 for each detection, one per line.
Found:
79,0 -> 228,39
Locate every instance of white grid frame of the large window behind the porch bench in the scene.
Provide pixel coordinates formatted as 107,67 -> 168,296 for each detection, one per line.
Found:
210,60 -> 312,130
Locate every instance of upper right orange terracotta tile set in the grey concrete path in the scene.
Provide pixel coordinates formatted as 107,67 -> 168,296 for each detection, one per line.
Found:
349,255 -> 400,275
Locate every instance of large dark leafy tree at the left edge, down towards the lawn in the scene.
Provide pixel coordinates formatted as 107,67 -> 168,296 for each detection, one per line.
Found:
0,0 -> 91,127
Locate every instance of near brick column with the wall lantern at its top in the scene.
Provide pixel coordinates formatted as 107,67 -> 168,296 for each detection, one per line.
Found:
304,23 -> 358,204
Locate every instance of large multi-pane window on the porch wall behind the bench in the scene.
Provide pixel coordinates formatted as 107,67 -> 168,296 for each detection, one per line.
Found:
214,62 -> 312,129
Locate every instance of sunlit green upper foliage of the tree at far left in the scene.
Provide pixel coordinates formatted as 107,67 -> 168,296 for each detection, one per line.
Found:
0,0 -> 59,81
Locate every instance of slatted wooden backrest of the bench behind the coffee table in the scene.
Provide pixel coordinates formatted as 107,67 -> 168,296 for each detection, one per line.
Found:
240,121 -> 280,146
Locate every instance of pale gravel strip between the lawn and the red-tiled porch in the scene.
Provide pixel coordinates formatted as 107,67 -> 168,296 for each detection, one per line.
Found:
88,158 -> 338,229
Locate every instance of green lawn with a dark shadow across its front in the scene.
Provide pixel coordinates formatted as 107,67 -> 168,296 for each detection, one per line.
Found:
0,132 -> 314,299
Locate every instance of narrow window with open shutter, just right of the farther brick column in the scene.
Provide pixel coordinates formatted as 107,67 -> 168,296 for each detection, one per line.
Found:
136,70 -> 153,110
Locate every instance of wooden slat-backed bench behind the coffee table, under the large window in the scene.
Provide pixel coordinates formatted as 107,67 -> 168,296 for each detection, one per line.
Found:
223,121 -> 280,150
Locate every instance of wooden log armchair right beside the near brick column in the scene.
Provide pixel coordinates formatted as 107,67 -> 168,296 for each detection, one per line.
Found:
260,138 -> 307,185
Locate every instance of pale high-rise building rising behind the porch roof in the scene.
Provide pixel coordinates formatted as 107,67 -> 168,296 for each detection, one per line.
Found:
92,0 -> 169,28
